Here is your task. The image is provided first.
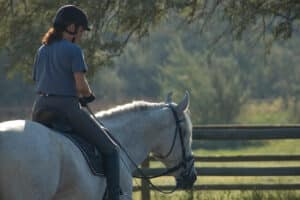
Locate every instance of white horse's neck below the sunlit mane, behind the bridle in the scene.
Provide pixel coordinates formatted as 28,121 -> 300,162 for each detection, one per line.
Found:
98,105 -> 171,171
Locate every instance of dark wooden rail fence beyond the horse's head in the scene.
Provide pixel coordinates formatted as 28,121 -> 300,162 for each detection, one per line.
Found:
134,125 -> 300,200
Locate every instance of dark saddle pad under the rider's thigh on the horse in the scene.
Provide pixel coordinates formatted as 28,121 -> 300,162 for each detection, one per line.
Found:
63,133 -> 105,176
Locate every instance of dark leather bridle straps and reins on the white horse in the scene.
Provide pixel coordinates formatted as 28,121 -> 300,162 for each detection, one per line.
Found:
86,104 -> 194,194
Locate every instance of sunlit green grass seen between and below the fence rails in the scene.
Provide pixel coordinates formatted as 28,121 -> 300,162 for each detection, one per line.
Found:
134,140 -> 300,200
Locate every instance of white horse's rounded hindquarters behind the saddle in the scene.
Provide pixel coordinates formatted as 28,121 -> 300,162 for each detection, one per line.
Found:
0,120 -> 60,200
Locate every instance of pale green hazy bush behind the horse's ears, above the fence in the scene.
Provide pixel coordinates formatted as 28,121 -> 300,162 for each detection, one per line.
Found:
161,34 -> 248,124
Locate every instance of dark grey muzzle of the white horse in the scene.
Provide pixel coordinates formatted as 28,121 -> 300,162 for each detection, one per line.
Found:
176,159 -> 197,190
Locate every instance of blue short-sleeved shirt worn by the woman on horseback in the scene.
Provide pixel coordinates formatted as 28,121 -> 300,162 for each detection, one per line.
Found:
33,39 -> 87,96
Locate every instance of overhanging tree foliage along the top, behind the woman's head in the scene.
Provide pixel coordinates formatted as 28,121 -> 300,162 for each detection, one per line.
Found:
0,0 -> 300,78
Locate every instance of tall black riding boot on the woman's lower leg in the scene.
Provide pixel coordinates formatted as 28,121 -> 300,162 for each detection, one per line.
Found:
104,148 -> 121,200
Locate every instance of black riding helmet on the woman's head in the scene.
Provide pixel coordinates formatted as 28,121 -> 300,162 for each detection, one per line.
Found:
53,5 -> 91,35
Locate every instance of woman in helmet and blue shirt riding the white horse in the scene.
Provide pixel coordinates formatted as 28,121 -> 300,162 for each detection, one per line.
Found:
32,5 -> 120,200
